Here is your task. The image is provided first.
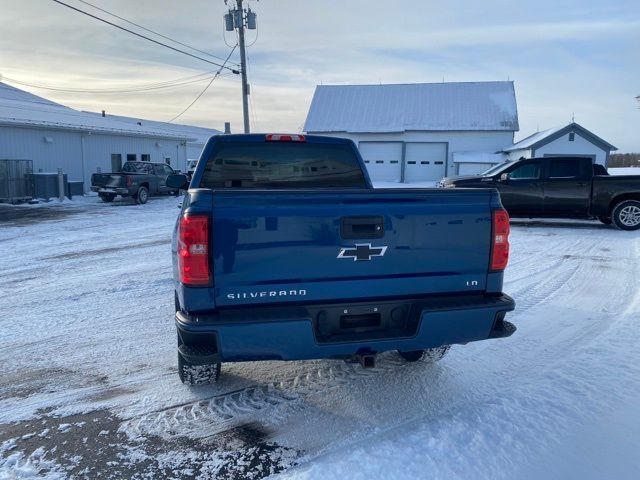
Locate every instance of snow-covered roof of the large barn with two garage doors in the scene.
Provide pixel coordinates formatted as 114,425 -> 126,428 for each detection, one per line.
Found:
304,82 -> 518,133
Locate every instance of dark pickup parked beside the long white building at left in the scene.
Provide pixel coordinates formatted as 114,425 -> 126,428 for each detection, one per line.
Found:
91,162 -> 178,204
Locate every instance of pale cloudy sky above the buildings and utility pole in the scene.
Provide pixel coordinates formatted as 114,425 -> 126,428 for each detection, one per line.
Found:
0,0 -> 640,152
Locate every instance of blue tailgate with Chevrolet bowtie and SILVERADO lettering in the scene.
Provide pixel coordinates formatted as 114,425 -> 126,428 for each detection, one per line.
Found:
212,189 -> 496,306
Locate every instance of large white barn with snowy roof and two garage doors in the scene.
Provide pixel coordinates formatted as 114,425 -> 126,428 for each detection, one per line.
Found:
304,82 -> 518,183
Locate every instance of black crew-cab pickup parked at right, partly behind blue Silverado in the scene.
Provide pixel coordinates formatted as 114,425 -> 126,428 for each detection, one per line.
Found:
440,157 -> 640,230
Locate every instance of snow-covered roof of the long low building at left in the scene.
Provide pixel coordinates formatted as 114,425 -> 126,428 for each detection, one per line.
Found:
0,82 -> 200,141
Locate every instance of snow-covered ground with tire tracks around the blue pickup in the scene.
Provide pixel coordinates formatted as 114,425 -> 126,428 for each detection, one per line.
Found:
0,193 -> 640,479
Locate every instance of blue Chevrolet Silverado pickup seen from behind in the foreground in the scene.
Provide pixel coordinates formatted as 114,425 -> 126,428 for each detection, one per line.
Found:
167,134 -> 515,384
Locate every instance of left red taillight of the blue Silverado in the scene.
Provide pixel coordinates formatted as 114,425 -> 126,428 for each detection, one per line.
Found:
178,215 -> 211,285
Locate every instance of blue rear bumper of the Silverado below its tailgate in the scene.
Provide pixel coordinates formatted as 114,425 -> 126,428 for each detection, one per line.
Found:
175,295 -> 515,362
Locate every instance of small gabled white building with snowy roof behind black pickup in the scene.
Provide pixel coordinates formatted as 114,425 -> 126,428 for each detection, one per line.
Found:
504,122 -> 617,167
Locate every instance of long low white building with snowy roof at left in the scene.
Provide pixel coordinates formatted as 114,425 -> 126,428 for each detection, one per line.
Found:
0,83 -> 221,191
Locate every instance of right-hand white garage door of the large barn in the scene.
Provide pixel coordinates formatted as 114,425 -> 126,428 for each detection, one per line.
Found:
404,143 -> 447,183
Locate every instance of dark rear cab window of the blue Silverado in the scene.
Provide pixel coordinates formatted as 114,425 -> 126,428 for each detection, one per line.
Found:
200,142 -> 367,189
